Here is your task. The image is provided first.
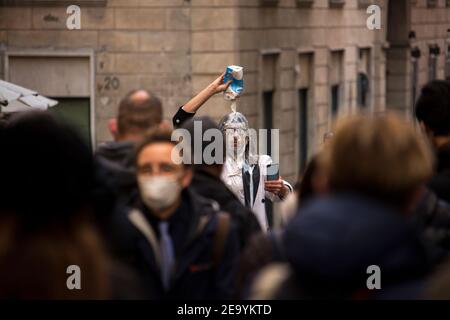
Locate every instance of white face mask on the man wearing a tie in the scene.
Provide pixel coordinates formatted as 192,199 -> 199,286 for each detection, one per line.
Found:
139,176 -> 182,212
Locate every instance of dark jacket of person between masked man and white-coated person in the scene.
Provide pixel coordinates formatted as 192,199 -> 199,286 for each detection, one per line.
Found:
191,169 -> 261,248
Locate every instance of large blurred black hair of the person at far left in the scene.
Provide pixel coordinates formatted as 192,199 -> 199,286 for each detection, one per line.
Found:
0,111 -> 93,227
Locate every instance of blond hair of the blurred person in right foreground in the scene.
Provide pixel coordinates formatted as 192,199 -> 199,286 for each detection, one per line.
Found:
325,114 -> 434,206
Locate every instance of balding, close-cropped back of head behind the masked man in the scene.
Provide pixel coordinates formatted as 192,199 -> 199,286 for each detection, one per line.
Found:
117,90 -> 163,135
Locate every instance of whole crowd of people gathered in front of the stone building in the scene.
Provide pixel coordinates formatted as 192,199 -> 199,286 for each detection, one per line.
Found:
0,75 -> 450,300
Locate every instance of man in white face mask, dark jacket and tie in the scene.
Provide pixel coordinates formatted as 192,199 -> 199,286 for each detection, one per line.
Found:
110,128 -> 239,299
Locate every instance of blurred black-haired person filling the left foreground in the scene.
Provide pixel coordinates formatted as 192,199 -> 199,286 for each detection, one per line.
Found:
0,111 -> 108,299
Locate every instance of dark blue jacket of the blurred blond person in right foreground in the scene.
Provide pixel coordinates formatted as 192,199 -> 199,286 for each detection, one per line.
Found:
283,194 -> 430,299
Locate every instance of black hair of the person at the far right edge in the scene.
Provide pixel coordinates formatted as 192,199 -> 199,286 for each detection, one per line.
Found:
415,80 -> 450,136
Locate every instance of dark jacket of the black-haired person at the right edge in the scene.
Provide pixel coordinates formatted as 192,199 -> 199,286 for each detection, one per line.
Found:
428,143 -> 450,202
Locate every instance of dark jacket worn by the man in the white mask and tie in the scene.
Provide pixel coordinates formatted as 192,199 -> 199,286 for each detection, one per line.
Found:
114,190 -> 239,300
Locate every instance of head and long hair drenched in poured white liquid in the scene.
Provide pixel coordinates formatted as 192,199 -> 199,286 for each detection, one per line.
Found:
219,112 -> 257,164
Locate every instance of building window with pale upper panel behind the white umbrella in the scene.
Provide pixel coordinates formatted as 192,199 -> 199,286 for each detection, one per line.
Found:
7,52 -> 96,148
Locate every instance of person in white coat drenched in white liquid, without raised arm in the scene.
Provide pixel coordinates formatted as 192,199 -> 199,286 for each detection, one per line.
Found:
219,112 -> 293,231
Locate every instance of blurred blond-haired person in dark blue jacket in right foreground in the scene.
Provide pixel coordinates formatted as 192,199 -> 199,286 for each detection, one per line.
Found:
283,115 -> 433,299
